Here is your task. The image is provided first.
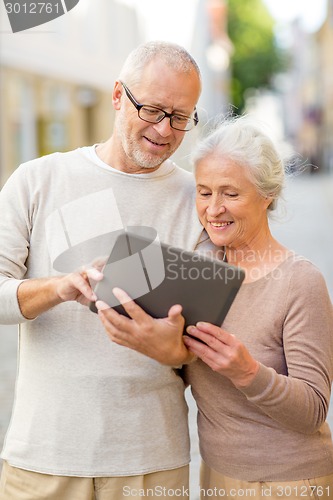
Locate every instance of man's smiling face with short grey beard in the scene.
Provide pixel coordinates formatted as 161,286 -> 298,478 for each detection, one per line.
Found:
114,61 -> 200,173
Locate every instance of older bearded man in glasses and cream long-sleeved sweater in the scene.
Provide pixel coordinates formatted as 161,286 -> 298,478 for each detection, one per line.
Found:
0,42 -> 201,500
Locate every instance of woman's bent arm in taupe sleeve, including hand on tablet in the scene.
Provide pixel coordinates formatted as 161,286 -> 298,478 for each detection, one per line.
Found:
185,261 -> 333,434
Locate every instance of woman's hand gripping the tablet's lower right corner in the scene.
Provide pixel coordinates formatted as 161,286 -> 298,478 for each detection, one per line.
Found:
184,322 -> 259,388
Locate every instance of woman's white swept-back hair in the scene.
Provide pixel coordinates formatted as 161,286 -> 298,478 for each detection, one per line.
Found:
191,115 -> 285,210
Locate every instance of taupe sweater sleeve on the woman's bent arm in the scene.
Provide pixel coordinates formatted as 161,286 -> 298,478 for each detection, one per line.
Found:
242,261 -> 333,434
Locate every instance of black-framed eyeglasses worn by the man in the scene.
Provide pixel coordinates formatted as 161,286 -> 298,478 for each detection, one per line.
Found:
120,81 -> 199,132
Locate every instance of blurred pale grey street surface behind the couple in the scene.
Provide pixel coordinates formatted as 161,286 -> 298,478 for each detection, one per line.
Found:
0,173 -> 333,500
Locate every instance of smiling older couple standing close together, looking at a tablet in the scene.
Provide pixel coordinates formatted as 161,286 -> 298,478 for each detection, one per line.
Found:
0,42 -> 333,500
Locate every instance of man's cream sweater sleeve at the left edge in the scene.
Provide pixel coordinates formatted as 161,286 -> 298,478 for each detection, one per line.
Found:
0,165 -> 31,324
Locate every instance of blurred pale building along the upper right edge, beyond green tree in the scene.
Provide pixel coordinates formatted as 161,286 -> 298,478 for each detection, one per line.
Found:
277,0 -> 333,172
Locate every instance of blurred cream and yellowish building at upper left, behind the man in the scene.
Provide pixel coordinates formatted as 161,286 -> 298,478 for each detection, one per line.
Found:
0,0 -> 142,186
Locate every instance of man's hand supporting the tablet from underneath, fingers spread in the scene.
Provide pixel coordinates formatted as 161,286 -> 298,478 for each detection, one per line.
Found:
96,288 -> 195,366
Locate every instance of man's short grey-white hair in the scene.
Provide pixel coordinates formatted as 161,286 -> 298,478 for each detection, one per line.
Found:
119,41 -> 201,85
